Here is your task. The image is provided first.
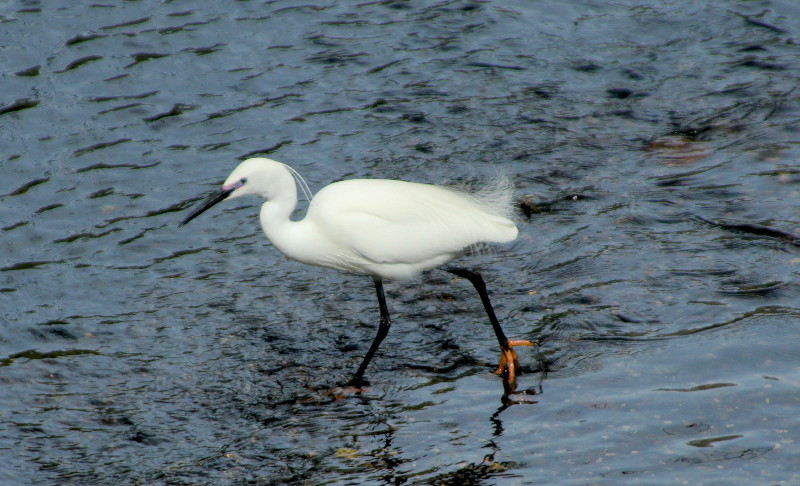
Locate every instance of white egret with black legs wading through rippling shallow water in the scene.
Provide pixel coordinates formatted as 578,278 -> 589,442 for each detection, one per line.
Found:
180,157 -> 535,388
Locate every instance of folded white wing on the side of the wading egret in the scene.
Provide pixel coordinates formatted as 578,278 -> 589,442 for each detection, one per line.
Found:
306,179 -> 517,263
